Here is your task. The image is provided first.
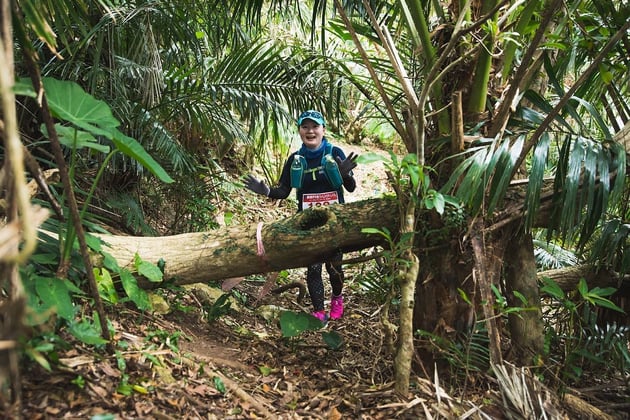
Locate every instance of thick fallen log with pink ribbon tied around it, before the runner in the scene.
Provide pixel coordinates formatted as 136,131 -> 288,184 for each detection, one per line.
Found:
95,198 -> 398,287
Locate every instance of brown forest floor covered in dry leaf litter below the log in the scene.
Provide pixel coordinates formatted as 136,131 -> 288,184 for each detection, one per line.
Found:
14,139 -> 627,420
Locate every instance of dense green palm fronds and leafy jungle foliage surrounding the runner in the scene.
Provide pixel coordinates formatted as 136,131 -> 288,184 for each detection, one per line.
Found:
0,0 -> 630,412
